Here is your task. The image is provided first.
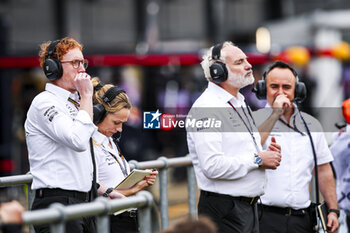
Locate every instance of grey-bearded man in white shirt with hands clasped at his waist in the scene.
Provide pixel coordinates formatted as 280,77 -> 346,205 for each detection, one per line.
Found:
186,42 -> 281,233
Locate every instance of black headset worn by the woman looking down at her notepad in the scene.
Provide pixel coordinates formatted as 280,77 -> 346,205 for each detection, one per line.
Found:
93,86 -> 125,125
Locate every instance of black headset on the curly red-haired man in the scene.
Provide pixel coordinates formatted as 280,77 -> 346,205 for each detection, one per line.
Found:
43,40 -> 63,81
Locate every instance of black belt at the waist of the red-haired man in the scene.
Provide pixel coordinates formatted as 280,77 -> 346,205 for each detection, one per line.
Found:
35,188 -> 90,202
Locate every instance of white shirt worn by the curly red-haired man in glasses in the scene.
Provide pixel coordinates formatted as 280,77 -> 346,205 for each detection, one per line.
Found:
24,83 -> 96,192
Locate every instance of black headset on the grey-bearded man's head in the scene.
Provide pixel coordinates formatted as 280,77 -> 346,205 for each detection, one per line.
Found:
209,43 -> 228,83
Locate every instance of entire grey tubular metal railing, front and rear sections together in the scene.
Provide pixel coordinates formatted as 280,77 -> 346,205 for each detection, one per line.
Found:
0,156 -> 197,233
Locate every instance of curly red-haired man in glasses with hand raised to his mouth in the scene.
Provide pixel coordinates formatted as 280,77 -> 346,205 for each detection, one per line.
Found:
25,38 -> 122,233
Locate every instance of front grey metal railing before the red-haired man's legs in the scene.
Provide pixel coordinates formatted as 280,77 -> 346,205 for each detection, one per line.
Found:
22,191 -> 159,233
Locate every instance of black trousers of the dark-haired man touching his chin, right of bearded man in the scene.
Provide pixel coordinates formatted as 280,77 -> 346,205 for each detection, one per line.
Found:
258,205 -> 315,233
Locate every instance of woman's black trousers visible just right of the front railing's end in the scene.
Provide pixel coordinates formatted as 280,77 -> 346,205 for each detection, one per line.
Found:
109,211 -> 139,233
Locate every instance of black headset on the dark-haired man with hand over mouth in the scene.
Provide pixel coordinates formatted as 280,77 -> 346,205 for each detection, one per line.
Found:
253,61 -> 306,103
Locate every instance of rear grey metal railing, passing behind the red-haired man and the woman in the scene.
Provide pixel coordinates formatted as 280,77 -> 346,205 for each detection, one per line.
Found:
0,156 -> 197,230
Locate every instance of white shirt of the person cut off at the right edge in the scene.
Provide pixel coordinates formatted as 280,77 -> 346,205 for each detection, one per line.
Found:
330,124 -> 350,212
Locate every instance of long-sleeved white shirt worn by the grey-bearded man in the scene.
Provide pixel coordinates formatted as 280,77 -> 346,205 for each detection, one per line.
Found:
186,82 -> 265,197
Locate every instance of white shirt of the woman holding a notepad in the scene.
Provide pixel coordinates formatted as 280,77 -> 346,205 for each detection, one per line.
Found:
93,131 -> 130,187
